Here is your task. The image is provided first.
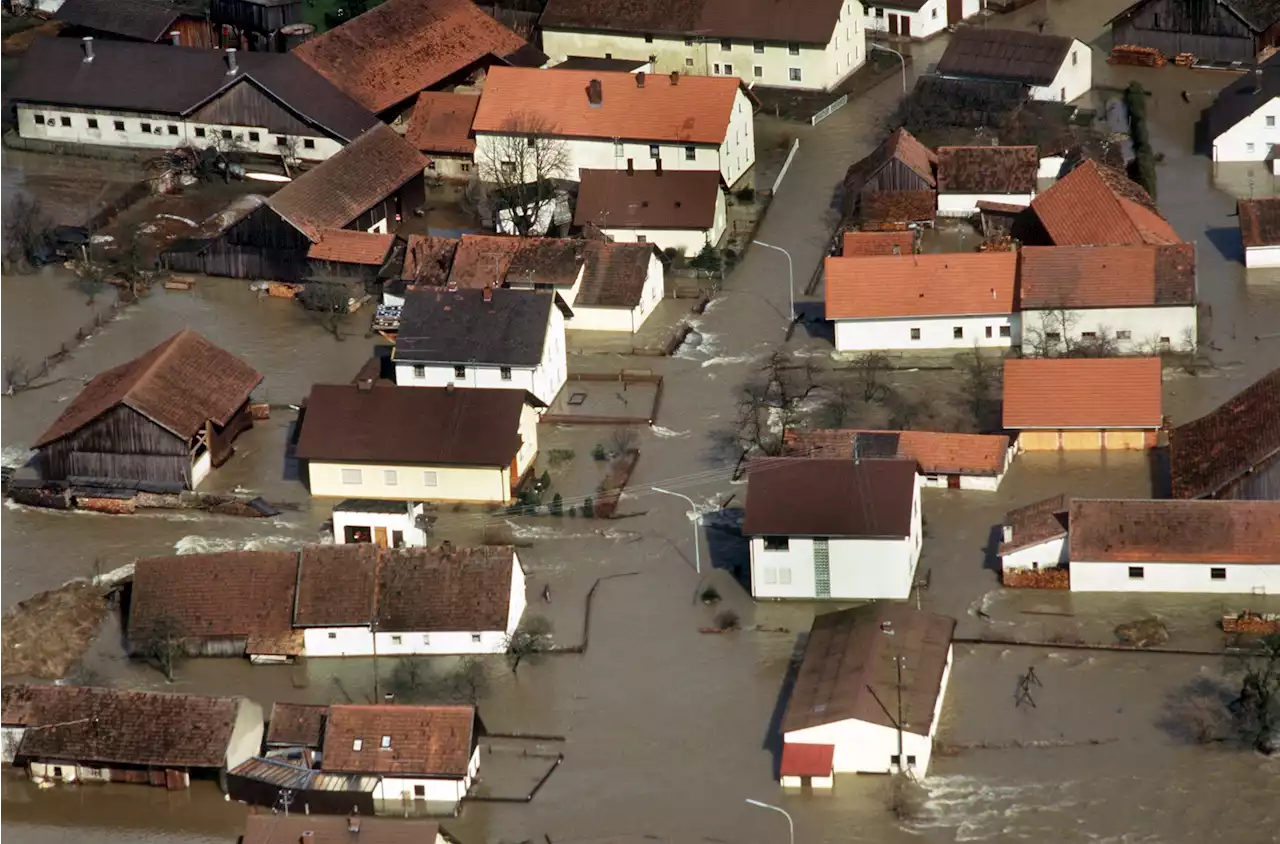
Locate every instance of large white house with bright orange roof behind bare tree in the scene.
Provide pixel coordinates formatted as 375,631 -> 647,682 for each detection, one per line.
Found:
471,67 -> 755,186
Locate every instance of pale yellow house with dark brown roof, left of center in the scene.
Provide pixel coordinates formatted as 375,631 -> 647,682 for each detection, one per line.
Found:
296,380 -> 541,503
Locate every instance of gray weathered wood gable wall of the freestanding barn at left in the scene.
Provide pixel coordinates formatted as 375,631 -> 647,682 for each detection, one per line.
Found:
40,405 -> 191,487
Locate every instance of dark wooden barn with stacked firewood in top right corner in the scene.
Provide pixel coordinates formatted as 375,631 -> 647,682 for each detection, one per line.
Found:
1110,0 -> 1280,64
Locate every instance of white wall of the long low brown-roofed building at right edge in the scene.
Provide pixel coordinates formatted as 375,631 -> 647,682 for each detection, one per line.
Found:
1070,556 -> 1280,594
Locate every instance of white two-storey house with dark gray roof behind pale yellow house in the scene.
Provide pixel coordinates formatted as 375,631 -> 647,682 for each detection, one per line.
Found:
392,285 -> 572,405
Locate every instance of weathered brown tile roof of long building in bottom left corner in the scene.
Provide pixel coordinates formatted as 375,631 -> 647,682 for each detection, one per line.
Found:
0,685 -> 242,768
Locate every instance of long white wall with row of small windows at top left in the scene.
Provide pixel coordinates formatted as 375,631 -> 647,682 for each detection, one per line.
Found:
18,104 -> 343,161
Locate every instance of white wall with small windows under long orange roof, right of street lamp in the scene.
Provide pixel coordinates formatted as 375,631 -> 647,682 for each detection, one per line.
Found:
835,314 -> 1021,352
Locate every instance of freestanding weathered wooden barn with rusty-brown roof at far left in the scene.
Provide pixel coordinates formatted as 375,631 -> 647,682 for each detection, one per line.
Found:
35,330 -> 262,489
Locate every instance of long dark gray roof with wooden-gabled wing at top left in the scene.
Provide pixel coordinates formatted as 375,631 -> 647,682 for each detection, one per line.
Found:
6,38 -> 378,141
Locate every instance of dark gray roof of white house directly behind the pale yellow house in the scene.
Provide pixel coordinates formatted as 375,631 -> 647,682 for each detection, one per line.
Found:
396,288 -> 556,366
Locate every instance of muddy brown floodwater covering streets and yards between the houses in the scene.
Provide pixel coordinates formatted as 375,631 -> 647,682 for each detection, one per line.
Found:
0,0 -> 1280,844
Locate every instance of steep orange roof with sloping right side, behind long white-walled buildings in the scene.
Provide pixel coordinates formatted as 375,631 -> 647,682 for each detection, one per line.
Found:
1032,159 -> 1183,246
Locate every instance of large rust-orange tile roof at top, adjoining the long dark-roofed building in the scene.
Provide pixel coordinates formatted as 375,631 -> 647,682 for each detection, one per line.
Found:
293,0 -> 526,111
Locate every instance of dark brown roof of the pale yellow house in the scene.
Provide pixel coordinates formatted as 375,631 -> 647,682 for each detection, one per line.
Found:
297,384 -> 525,467
